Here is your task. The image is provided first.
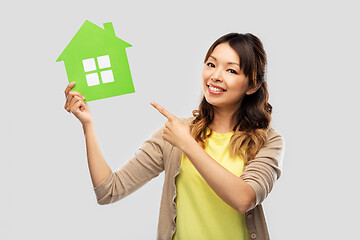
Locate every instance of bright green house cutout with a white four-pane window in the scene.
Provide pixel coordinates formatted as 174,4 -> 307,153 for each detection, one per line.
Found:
56,21 -> 135,102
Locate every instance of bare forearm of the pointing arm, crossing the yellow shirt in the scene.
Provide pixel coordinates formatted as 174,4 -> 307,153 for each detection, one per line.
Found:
183,140 -> 255,213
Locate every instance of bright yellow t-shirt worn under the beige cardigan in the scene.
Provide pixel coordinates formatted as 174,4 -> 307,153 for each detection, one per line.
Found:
173,131 -> 249,240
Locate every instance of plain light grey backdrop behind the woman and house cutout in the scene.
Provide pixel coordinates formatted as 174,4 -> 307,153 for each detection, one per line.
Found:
0,1 -> 360,240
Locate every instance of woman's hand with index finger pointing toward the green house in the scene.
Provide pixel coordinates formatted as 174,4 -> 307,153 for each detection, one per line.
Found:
150,102 -> 196,151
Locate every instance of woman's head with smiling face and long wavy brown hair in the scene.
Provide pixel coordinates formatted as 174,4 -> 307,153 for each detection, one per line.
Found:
192,33 -> 272,164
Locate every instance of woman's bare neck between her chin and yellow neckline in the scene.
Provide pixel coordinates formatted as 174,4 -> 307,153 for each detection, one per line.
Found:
209,106 -> 236,133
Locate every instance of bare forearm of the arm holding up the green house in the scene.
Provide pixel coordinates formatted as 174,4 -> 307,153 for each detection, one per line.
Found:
83,122 -> 112,187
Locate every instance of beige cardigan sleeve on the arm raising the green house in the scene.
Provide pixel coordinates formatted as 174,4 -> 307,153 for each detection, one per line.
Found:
93,128 -> 164,205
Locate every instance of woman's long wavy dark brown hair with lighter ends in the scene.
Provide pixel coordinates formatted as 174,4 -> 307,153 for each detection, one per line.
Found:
191,33 -> 272,164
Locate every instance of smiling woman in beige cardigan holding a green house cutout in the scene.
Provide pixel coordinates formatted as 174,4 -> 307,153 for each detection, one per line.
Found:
65,33 -> 284,240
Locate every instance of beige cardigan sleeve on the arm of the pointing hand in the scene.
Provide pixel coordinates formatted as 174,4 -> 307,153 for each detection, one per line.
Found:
240,128 -> 285,207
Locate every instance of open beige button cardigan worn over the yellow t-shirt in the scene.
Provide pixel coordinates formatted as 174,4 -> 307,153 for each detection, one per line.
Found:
94,118 -> 284,240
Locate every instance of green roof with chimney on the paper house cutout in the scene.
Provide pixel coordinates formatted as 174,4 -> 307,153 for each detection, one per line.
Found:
56,20 -> 131,62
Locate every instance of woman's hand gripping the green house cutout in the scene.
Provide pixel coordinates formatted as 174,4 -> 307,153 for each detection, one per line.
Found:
64,82 -> 92,125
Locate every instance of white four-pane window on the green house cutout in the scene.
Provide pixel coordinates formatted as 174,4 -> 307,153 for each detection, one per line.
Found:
82,55 -> 114,87
